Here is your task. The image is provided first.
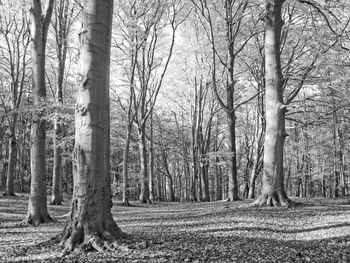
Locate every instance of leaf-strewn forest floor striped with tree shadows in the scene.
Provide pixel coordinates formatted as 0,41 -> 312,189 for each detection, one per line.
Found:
0,196 -> 350,263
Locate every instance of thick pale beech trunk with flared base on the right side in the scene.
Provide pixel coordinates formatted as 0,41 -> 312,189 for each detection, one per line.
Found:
254,0 -> 291,206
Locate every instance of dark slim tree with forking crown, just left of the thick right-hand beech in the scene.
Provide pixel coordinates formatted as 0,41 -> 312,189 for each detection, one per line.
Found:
192,0 -> 257,201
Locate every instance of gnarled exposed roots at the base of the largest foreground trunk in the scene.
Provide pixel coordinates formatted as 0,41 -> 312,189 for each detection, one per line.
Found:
57,221 -> 129,255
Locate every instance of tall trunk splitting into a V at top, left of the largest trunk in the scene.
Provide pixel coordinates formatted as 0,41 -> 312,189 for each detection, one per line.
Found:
24,0 -> 54,225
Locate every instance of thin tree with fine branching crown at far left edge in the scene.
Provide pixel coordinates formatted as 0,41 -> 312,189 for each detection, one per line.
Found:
0,2 -> 30,195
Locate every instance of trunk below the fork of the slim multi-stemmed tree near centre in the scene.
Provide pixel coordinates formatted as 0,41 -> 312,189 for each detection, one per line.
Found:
138,125 -> 149,203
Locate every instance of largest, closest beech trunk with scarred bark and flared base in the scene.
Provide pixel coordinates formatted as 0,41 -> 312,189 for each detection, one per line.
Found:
61,0 -> 125,251
